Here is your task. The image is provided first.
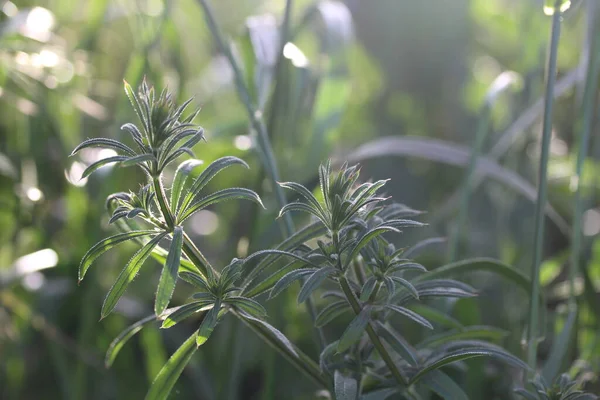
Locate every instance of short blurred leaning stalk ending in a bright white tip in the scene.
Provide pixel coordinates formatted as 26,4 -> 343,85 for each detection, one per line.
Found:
448,103 -> 490,263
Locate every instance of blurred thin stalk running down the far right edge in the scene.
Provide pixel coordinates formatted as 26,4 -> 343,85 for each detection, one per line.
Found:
569,2 -> 600,305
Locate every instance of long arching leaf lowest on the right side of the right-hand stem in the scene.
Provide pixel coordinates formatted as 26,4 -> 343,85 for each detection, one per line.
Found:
410,340 -> 529,384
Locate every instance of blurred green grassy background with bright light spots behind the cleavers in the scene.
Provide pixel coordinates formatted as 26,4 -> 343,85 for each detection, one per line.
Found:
0,0 -> 600,400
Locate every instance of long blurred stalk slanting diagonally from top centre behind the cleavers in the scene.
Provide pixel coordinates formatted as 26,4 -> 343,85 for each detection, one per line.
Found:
198,0 -> 326,350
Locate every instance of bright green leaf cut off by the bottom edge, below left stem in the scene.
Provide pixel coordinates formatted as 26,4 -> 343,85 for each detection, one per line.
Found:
146,332 -> 198,400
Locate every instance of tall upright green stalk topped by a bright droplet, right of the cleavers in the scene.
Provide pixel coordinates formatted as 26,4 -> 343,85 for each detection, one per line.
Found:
527,2 -> 562,371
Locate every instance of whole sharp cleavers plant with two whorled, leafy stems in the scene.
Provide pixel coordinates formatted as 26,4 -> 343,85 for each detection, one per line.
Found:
73,82 -> 592,400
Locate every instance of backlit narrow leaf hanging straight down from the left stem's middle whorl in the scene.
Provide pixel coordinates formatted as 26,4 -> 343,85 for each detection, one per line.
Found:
154,226 -> 183,315
